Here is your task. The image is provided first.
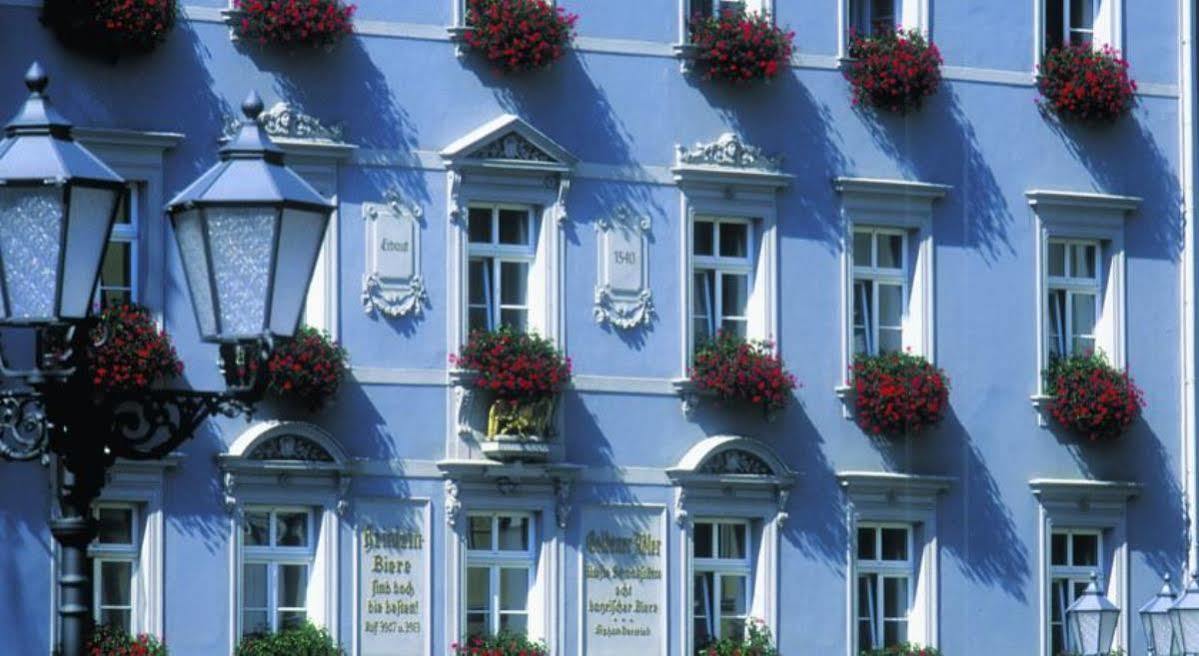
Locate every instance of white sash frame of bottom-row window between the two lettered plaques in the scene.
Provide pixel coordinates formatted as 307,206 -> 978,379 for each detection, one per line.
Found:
459,511 -> 537,636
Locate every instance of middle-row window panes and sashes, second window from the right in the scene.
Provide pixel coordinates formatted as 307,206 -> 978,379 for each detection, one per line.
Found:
852,228 -> 908,355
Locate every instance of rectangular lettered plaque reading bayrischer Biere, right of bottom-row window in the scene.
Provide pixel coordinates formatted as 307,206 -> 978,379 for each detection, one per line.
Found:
579,506 -> 667,656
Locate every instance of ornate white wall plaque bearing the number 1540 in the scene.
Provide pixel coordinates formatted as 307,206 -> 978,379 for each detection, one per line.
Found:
595,206 -> 655,330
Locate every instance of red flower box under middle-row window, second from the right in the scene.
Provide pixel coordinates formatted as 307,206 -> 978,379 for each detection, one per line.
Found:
850,353 -> 950,437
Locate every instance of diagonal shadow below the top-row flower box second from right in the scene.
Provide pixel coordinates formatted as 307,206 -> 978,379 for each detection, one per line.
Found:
854,82 -> 1016,261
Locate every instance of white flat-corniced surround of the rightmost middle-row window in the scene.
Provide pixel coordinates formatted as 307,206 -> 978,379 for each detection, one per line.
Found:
1025,189 -> 1140,400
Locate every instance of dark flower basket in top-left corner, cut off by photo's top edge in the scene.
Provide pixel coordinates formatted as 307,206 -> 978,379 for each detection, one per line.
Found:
42,0 -> 179,58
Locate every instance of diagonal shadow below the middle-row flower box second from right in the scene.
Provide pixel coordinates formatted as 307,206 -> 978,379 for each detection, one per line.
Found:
872,407 -> 1032,602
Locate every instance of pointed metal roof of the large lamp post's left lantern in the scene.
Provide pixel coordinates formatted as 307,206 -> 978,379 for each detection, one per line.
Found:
0,61 -> 125,185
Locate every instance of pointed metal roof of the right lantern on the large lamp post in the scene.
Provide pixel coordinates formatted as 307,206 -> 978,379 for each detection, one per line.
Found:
167,92 -> 333,211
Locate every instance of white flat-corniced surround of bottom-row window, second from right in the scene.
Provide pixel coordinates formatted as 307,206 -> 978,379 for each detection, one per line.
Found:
837,471 -> 954,656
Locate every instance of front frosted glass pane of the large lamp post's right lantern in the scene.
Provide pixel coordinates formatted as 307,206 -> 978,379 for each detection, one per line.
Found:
207,207 -> 275,337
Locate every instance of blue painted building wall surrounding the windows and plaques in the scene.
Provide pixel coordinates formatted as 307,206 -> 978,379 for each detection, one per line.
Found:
0,0 -> 1185,656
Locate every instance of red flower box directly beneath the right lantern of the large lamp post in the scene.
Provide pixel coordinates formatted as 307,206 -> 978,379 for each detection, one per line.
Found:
266,326 -> 349,410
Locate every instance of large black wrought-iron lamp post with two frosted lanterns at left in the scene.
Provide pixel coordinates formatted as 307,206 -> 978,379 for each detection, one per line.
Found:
0,64 -> 333,656
